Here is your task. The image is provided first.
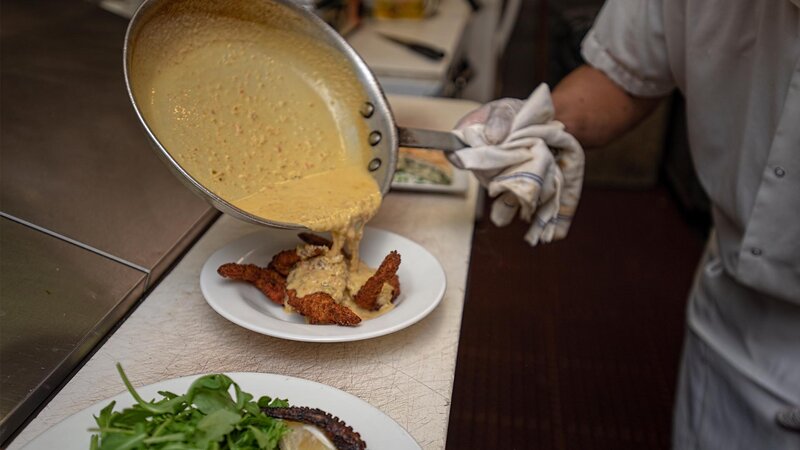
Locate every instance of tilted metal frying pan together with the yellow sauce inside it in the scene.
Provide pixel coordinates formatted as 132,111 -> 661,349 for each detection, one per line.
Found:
124,0 -> 465,237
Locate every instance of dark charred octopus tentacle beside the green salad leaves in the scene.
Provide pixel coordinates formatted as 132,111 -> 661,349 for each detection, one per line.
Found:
261,406 -> 367,450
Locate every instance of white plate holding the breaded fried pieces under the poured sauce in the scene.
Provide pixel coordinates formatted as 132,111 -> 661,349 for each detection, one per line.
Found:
200,228 -> 446,342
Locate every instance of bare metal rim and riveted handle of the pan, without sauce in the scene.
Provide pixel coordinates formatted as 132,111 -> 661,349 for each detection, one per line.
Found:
124,0 -> 466,229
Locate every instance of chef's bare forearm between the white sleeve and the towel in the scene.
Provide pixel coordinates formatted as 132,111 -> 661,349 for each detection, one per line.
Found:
552,65 -> 662,148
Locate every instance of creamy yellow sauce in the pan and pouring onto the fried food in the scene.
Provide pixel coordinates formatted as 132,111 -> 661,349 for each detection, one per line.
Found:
131,0 -> 393,319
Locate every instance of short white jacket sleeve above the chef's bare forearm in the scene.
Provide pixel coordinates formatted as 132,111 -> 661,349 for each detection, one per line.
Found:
581,0 -> 675,97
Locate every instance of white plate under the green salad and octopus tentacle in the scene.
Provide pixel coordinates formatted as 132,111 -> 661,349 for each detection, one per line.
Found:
24,372 -> 420,450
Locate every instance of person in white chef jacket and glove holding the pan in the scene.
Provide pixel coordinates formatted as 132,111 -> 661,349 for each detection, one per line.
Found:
452,0 -> 800,450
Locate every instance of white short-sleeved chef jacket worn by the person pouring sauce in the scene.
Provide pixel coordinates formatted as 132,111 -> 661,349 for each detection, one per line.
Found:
582,0 -> 800,414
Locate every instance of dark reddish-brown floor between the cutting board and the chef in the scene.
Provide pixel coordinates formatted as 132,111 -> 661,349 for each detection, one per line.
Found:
447,188 -> 703,450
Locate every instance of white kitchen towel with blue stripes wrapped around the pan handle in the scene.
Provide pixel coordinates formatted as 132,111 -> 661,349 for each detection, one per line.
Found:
448,84 -> 584,245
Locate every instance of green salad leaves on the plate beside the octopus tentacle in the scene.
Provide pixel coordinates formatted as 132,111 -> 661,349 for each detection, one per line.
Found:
89,364 -> 289,450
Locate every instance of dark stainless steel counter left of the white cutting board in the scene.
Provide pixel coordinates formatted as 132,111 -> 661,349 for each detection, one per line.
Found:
0,0 -> 217,443
